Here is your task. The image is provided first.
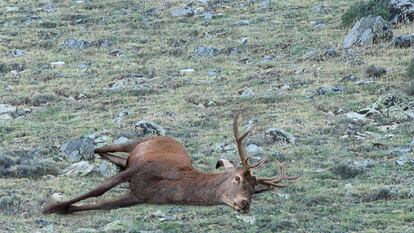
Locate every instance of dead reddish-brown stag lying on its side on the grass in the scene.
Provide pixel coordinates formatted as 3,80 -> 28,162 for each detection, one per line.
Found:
43,113 -> 298,214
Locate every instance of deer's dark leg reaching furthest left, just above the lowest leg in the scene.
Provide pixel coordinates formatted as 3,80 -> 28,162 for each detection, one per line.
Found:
42,168 -> 136,214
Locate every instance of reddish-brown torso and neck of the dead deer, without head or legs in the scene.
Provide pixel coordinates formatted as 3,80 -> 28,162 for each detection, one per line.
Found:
126,136 -> 230,205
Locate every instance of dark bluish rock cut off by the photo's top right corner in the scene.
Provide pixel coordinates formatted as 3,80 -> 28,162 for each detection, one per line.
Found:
388,0 -> 414,24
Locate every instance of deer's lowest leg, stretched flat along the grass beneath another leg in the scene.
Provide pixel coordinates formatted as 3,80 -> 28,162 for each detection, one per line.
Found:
67,192 -> 141,213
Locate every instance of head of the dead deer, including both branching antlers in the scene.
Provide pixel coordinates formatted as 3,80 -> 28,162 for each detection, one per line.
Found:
216,112 -> 299,213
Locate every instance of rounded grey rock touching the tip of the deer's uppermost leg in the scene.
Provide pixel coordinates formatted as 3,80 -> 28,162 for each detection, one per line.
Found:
59,137 -> 95,162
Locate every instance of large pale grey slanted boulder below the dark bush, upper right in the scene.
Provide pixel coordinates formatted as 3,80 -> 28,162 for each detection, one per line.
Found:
343,15 -> 393,49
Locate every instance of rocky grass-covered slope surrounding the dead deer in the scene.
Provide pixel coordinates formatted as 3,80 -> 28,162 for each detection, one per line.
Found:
0,0 -> 414,232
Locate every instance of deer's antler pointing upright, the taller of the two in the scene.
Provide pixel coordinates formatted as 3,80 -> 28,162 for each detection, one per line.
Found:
233,111 -> 264,170
